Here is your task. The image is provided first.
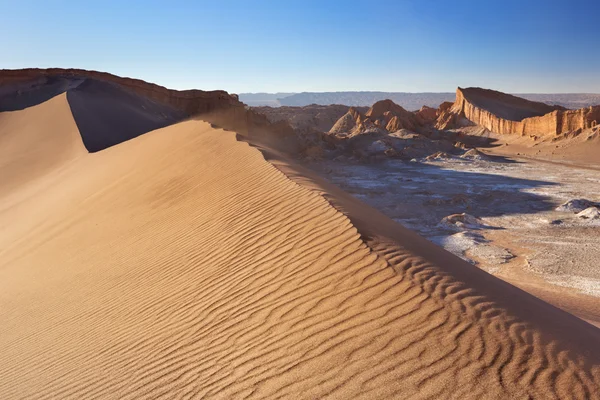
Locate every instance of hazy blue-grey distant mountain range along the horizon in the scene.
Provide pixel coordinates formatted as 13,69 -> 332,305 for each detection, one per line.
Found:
239,92 -> 600,110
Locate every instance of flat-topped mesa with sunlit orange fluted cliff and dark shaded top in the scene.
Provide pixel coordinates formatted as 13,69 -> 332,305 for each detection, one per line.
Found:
436,88 -> 600,135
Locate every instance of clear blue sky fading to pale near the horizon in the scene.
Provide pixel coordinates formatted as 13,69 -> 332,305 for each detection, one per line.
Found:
0,0 -> 600,93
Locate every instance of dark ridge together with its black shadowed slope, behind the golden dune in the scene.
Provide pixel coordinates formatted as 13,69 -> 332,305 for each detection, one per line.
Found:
0,68 -> 298,152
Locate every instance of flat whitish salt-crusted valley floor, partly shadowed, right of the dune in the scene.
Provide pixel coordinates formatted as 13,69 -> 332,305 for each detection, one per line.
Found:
311,156 -> 600,324
